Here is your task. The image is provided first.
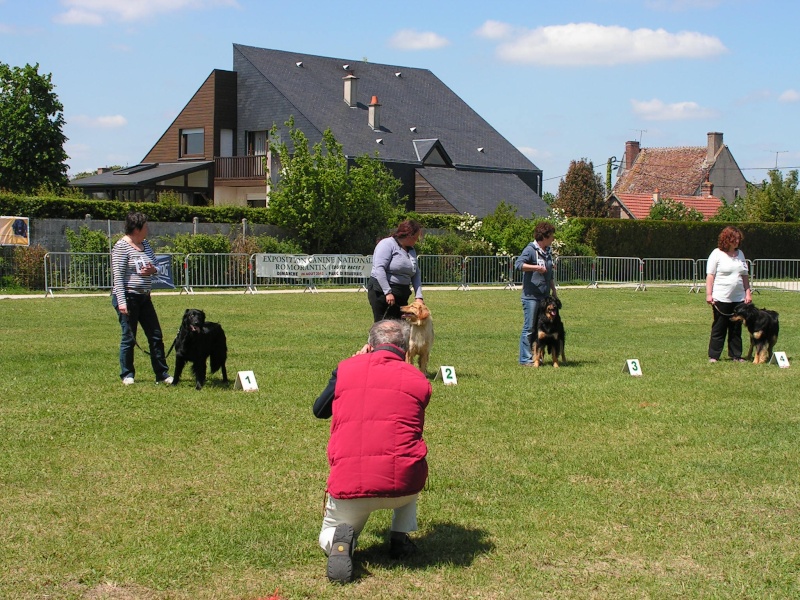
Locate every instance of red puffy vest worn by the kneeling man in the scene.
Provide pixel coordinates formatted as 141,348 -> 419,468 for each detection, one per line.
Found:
328,350 -> 431,499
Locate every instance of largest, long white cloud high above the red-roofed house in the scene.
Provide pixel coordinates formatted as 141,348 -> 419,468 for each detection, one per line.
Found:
478,21 -> 727,66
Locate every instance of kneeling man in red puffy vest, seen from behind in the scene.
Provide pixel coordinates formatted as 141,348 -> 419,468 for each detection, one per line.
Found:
314,320 -> 431,583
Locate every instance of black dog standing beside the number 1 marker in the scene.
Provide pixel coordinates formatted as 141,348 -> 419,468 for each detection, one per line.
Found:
172,308 -> 228,390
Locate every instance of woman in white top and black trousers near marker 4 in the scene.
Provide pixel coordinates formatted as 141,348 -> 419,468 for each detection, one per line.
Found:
706,226 -> 752,362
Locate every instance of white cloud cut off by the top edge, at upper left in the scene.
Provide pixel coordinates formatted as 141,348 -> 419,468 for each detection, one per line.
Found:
53,0 -> 239,25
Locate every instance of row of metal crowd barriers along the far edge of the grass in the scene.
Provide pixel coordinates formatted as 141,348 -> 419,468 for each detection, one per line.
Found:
10,252 -> 800,296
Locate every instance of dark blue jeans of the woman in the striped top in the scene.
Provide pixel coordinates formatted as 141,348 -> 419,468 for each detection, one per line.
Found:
111,294 -> 169,381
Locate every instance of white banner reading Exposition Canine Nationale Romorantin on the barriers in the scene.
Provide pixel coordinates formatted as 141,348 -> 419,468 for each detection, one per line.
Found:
256,254 -> 372,279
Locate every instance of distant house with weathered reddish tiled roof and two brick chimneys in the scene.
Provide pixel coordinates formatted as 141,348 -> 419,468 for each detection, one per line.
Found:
608,132 -> 747,219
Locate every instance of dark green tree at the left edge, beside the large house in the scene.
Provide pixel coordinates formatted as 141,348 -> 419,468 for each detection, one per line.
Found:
0,62 -> 67,193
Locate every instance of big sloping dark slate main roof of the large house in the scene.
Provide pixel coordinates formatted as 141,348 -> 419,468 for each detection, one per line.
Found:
234,44 -> 541,172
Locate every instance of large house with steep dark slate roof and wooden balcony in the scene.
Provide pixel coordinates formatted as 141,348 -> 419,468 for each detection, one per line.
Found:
71,44 -> 547,217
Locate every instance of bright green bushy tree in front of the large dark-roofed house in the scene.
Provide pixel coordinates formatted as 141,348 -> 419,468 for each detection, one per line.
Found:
267,119 -> 404,254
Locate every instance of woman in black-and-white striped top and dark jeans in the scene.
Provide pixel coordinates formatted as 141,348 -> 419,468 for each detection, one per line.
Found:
111,212 -> 172,385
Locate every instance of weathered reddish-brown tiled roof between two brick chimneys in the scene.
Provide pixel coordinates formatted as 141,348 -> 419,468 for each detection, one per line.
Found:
614,146 -> 710,198
